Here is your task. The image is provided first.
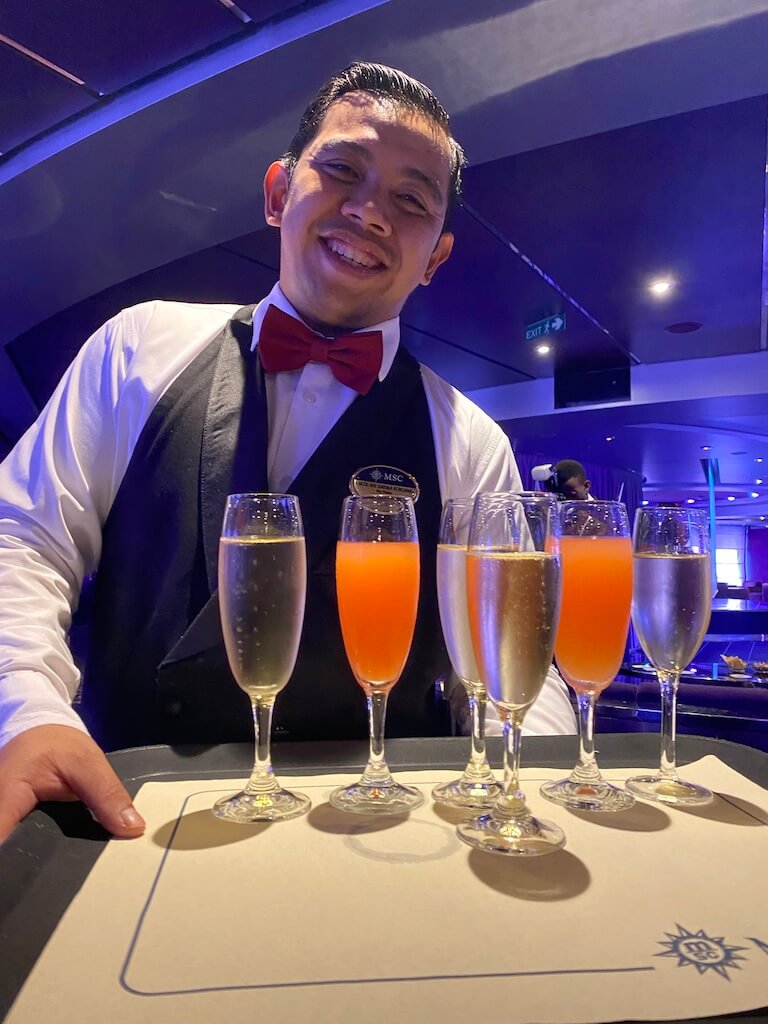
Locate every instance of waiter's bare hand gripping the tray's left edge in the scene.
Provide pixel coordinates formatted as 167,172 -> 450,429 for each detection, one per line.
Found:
0,725 -> 144,843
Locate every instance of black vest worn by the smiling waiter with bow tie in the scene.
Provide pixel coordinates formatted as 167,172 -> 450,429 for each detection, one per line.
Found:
82,307 -> 447,750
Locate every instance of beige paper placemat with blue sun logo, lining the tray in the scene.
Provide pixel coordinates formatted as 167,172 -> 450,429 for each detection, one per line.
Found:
8,757 -> 768,1024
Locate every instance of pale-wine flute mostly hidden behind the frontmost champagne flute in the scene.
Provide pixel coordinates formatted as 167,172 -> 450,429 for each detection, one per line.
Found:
432,499 -> 502,809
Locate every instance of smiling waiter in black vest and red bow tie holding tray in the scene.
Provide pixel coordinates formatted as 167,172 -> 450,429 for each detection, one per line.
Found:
0,63 -> 574,839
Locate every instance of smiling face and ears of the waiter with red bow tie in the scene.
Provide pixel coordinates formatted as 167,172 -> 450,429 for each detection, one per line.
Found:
264,92 -> 454,334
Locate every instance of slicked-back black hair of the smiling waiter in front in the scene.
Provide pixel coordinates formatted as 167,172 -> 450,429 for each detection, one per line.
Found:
282,60 -> 467,229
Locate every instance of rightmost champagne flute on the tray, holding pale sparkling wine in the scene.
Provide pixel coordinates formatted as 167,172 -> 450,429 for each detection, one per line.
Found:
626,506 -> 712,806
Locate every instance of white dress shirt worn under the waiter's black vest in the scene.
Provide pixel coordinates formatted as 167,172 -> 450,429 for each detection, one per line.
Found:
0,286 -> 575,744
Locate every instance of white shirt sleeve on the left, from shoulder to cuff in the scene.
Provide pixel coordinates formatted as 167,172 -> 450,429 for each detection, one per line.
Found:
0,302 -> 237,744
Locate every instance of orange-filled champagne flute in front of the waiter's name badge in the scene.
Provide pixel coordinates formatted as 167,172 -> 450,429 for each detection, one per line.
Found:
330,495 -> 424,814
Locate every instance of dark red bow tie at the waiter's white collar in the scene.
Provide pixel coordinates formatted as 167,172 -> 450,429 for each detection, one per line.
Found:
259,305 -> 383,394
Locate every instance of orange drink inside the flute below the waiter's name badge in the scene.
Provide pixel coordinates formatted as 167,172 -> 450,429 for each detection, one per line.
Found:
336,541 -> 419,690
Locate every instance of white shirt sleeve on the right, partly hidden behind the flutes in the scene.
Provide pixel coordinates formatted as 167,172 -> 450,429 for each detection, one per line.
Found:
421,366 -> 577,735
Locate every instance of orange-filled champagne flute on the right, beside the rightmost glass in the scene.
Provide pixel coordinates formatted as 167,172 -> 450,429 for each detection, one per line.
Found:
541,501 -> 635,811
